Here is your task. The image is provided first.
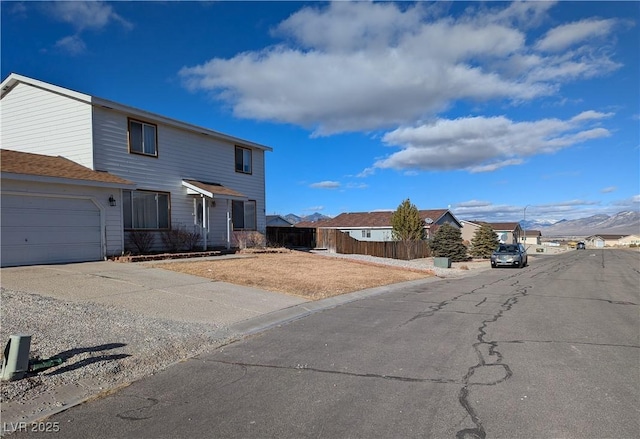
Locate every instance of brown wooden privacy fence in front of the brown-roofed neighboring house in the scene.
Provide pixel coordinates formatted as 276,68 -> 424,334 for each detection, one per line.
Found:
316,229 -> 431,260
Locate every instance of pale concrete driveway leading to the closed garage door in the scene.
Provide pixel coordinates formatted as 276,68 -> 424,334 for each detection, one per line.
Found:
0,256 -> 306,326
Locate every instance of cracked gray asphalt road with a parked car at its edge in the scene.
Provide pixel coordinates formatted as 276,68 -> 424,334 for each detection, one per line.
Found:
11,250 -> 640,439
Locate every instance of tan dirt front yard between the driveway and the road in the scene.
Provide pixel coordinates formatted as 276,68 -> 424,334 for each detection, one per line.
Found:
154,251 -> 433,300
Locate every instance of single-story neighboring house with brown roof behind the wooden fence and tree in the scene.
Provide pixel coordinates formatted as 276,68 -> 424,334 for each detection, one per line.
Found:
295,209 -> 462,242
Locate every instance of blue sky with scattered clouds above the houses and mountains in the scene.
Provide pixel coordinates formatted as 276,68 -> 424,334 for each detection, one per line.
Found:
1,1 -> 640,221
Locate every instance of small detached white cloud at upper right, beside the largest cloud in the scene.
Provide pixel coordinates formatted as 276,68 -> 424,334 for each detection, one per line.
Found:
536,19 -> 616,52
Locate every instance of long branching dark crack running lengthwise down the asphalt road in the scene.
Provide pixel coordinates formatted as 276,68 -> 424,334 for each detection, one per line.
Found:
456,281 -> 528,439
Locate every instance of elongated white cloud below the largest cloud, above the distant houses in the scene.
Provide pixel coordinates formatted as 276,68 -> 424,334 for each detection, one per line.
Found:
374,112 -> 610,172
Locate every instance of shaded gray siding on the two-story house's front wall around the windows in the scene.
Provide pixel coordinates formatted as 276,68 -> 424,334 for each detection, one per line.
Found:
93,107 -> 266,246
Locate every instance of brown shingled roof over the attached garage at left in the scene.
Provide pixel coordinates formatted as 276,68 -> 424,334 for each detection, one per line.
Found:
0,149 -> 134,186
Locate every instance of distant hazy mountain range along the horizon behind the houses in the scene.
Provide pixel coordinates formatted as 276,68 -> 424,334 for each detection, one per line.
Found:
284,210 -> 640,236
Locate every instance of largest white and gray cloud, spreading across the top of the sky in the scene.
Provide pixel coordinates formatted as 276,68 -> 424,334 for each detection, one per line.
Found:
179,2 -> 619,135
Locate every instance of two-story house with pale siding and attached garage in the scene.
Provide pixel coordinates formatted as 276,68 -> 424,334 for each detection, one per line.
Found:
0,74 -> 272,266
